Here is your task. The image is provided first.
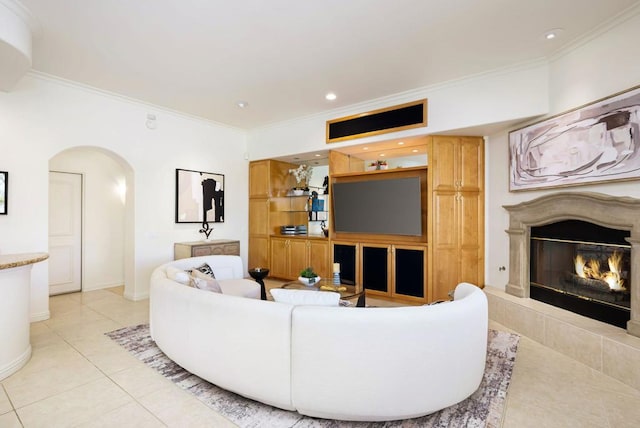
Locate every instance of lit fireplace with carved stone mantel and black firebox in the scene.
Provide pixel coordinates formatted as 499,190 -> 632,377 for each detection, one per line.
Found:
504,192 -> 640,337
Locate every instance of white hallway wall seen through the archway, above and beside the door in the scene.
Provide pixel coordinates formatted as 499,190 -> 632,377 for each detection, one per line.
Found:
49,147 -> 126,291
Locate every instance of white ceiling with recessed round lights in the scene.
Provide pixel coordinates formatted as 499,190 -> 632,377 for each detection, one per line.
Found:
22,0 -> 640,129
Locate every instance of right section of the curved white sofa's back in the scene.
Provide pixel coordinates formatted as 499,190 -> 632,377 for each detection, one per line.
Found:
291,283 -> 488,420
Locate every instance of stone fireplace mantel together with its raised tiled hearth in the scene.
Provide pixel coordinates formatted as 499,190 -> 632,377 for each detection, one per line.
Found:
485,192 -> 640,390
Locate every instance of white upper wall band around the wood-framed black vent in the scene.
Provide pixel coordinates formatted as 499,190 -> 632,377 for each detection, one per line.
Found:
248,63 -> 549,160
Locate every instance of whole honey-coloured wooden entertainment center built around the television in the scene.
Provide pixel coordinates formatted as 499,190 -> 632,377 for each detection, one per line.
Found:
249,136 -> 484,303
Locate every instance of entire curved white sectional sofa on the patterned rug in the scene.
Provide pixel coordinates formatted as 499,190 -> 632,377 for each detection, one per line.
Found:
150,256 -> 488,421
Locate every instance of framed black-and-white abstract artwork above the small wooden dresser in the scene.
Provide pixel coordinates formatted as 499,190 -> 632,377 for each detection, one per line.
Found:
176,169 -> 224,223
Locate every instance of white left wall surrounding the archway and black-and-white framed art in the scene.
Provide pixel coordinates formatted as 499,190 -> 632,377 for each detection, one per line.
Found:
0,74 -> 248,319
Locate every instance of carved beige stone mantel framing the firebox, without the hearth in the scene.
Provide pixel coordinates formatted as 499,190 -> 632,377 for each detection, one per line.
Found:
503,192 -> 640,337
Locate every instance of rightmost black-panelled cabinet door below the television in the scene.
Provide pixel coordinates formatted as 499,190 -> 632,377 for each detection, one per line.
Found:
392,246 -> 427,299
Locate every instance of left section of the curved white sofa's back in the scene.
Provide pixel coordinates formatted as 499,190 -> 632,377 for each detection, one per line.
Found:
149,256 -> 295,410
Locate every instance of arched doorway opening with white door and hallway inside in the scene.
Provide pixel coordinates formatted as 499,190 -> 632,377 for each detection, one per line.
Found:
49,146 -> 133,295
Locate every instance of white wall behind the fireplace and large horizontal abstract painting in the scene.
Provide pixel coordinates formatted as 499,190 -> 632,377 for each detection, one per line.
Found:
485,10 -> 640,288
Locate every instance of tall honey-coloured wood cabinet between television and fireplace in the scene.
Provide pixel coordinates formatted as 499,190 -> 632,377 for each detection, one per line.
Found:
429,136 -> 484,300
